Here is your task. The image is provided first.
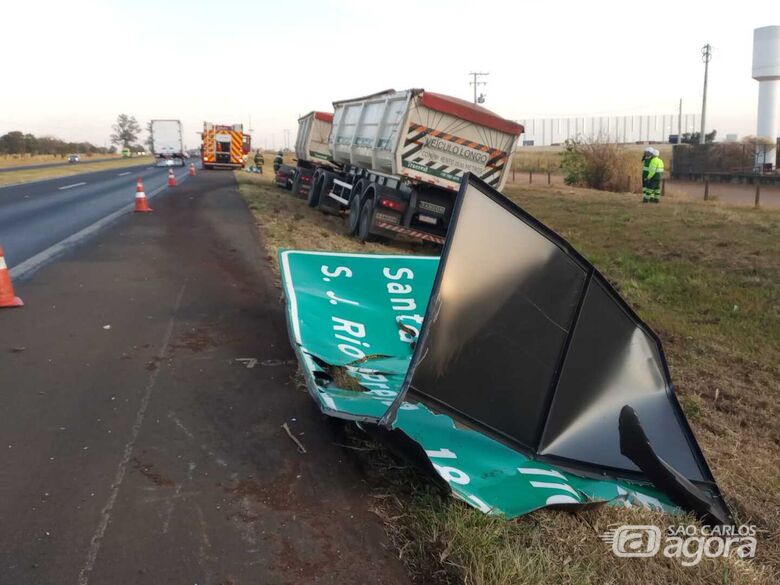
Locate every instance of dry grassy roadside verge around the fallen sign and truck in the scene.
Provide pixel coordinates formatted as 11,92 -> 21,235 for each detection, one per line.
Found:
237,165 -> 780,585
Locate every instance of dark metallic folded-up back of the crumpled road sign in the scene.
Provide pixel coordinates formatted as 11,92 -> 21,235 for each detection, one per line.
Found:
383,175 -> 730,523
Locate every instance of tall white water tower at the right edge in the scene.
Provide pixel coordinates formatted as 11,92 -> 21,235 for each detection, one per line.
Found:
753,26 -> 780,171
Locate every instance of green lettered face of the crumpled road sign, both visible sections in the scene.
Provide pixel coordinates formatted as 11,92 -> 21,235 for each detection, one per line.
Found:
279,250 -> 676,517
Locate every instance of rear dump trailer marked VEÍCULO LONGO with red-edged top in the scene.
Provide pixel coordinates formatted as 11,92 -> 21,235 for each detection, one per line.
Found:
296,89 -> 523,244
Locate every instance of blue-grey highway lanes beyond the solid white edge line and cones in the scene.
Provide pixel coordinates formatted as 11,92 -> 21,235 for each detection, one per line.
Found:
0,164 -> 193,277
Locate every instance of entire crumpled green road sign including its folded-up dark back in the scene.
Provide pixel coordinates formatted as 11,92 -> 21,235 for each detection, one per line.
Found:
280,176 -> 731,524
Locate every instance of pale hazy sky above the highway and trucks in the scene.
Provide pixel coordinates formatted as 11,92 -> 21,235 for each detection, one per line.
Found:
0,0 -> 780,148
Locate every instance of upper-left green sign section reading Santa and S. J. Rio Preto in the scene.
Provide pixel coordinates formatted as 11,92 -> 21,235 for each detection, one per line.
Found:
279,250 -> 439,422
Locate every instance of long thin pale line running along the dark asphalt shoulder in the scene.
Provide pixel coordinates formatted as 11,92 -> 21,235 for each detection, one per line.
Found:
78,285 -> 186,585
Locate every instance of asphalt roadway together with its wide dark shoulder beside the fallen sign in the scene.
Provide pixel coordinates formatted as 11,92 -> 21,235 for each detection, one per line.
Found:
0,169 -> 410,585
